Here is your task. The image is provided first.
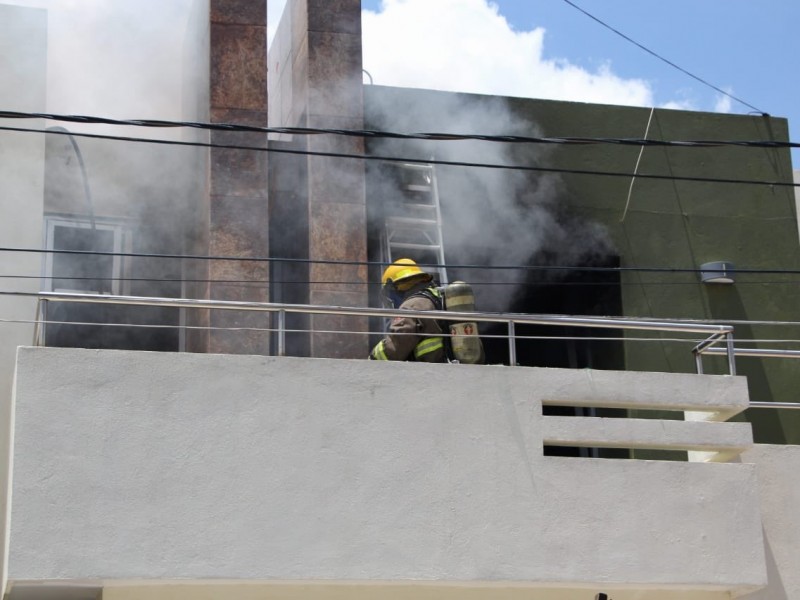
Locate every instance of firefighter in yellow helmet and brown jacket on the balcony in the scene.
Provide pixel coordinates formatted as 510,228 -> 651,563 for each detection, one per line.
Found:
369,258 -> 447,362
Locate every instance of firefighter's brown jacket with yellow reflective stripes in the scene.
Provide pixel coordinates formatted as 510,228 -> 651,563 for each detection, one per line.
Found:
369,288 -> 446,362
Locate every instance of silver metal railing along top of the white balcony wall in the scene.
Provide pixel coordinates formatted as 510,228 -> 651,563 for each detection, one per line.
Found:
36,292 -> 736,375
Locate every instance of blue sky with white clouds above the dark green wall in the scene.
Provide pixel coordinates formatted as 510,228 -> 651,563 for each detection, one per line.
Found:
354,0 -> 800,169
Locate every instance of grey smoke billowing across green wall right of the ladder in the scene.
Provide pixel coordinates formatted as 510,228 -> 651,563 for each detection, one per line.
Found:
365,88 -> 613,310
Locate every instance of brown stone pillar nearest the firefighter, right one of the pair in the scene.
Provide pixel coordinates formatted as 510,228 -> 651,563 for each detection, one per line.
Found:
302,0 -> 368,358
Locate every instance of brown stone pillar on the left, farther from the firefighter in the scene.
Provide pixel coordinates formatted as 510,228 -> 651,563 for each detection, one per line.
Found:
208,0 -> 269,354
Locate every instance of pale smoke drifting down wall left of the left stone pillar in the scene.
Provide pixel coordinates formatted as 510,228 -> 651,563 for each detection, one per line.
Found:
3,0 -> 208,332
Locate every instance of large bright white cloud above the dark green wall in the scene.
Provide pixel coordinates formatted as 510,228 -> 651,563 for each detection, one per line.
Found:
362,0 -> 654,106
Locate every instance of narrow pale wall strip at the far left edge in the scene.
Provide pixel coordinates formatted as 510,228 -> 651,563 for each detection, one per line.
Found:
0,4 -> 47,592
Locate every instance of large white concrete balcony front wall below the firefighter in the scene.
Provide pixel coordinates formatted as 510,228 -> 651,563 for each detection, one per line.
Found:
9,348 -> 766,593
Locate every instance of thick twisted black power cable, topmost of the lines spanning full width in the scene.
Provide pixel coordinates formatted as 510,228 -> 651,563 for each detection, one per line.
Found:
0,111 -> 800,148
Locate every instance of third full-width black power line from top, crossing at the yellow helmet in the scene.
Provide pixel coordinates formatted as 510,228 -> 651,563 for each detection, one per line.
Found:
0,246 -> 800,279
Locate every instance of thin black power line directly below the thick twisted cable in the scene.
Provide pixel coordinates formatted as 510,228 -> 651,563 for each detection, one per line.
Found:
0,127 -> 800,188
